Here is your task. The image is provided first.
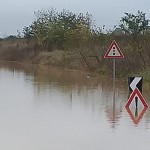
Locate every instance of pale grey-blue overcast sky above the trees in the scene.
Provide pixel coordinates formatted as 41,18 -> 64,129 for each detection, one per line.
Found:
0,0 -> 150,36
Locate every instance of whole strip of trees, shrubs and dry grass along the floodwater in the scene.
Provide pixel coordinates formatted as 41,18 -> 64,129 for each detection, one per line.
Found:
0,9 -> 150,78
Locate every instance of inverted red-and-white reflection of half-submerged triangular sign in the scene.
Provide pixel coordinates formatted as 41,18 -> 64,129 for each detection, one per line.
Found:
126,107 -> 148,124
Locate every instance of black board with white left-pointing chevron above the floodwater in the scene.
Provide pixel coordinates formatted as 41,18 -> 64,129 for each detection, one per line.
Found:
128,77 -> 143,93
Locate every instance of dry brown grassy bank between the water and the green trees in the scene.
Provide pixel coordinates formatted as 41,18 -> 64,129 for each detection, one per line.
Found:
0,39 -> 150,78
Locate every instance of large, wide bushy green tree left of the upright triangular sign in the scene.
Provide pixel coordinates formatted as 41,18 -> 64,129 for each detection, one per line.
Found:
23,9 -> 92,50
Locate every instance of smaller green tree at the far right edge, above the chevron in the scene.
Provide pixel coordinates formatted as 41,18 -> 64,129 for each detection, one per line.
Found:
120,11 -> 149,66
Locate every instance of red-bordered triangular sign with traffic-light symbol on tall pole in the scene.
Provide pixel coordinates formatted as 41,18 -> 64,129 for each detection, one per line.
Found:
104,41 -> 124,58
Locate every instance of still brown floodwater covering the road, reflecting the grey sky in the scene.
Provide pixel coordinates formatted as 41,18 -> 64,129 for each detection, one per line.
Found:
0,62 -> 150,150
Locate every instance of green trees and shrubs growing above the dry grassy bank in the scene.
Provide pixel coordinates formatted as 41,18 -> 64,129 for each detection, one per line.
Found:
1,8 -> 150,75
